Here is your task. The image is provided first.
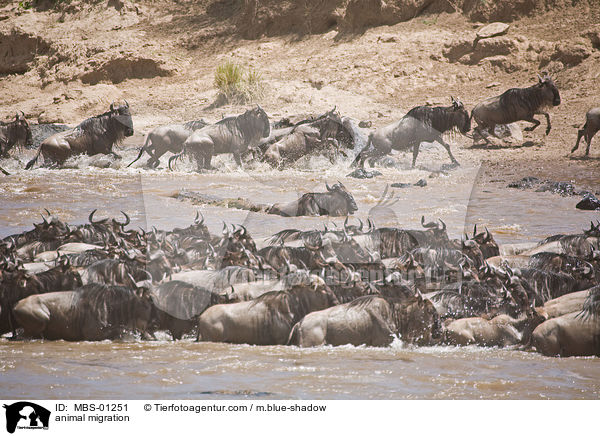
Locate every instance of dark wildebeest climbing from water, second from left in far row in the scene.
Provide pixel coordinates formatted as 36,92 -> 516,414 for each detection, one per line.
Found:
25,102 -> 133,169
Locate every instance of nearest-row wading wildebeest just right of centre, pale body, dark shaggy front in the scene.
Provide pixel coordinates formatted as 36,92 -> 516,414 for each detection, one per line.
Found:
288,295 -> 441,347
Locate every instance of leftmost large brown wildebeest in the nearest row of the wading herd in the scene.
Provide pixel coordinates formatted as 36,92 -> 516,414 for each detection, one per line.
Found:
13,283 -> 153,341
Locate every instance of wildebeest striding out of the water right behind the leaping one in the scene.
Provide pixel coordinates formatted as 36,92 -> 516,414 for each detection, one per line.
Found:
353,98 -> 471,167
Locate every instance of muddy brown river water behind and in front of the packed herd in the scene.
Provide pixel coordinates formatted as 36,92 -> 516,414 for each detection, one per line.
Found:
0,143 -> 600,399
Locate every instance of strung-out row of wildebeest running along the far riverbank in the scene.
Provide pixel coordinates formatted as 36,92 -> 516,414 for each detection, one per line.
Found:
0,76 -> 600,174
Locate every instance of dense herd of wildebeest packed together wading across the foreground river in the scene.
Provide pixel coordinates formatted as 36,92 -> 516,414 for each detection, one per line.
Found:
0,211 -> 600,356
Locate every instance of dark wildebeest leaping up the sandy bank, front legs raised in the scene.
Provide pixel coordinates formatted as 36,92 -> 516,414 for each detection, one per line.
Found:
471,76 -> 560,144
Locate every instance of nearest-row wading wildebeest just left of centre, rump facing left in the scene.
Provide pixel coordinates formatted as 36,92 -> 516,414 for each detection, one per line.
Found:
198,276 -> 338,345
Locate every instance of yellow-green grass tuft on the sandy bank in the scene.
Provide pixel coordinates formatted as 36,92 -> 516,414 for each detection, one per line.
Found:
215,61 -> 263,104
